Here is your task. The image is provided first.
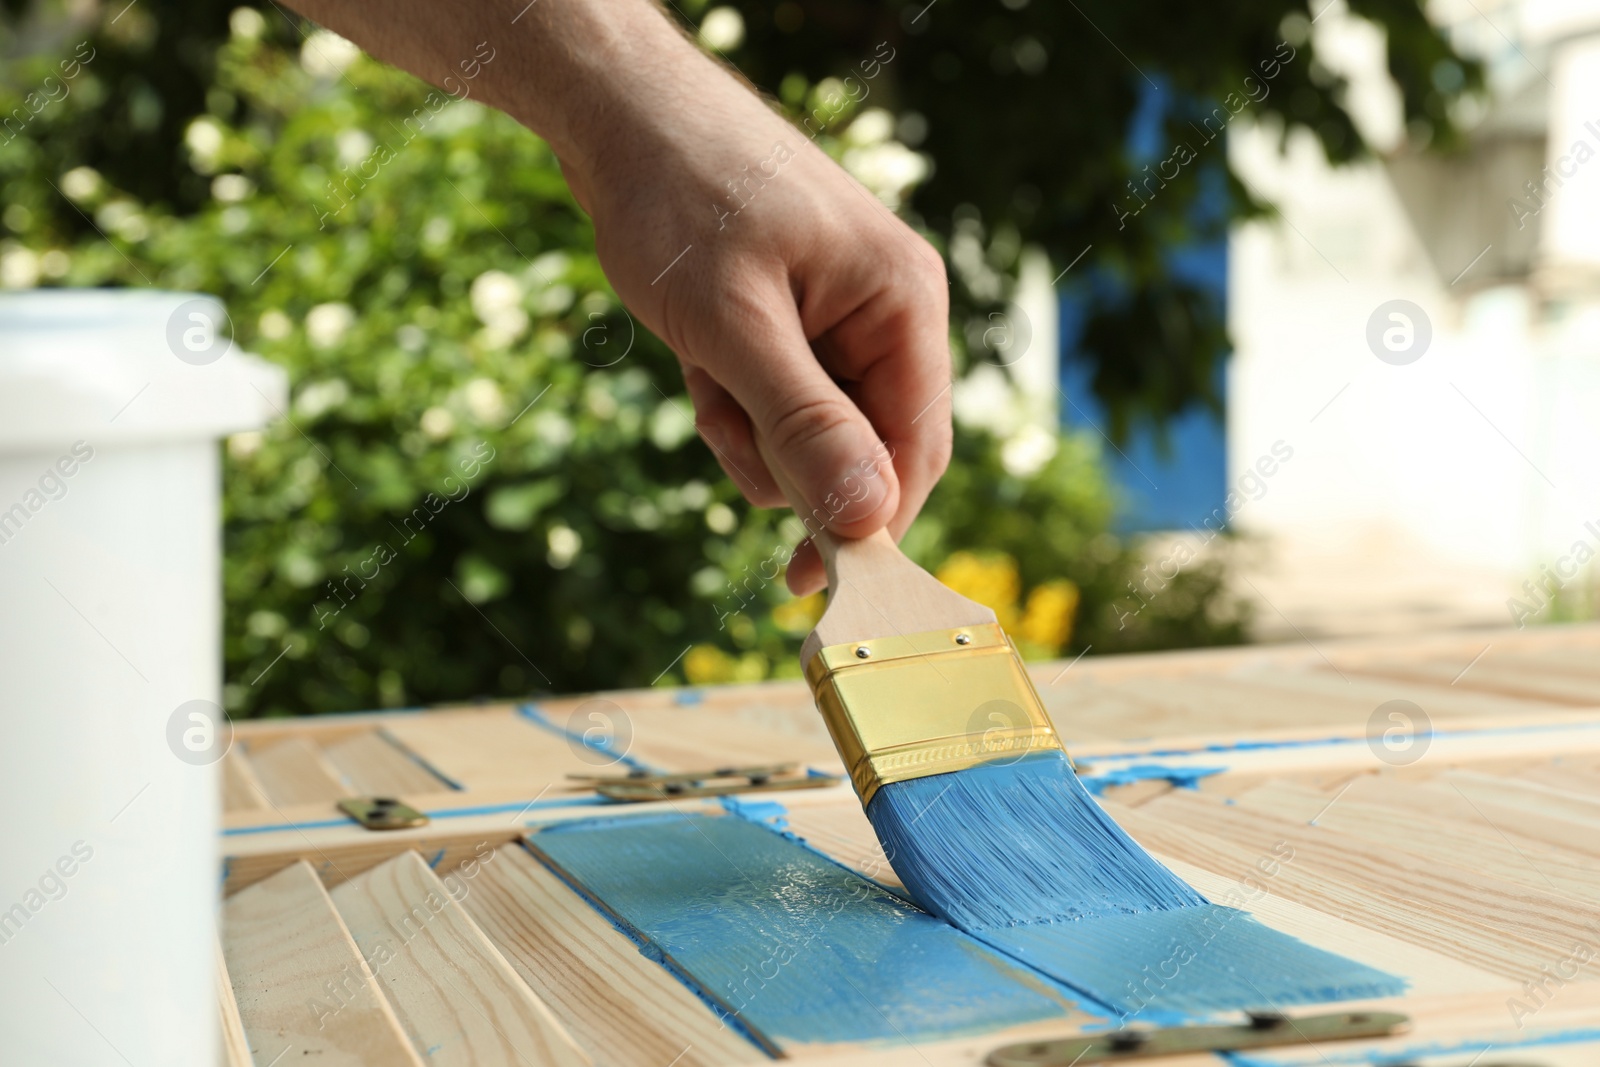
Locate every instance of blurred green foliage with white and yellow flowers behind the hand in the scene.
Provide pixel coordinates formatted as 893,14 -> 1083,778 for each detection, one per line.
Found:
0,3 -> 1472,715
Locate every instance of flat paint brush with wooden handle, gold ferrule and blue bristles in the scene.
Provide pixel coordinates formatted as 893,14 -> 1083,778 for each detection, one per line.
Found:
768,461 -> 1205,931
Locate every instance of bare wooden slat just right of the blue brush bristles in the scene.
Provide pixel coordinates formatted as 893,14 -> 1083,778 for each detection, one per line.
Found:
1126,790 -> 1582,976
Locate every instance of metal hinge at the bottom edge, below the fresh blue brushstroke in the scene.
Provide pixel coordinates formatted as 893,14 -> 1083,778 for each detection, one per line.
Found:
984,1011 -> 1411,1067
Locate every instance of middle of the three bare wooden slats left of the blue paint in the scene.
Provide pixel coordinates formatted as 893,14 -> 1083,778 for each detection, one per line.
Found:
333,853 -> 589,1067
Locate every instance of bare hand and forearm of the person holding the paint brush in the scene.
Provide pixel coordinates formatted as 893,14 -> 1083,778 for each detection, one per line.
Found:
284,0 -> 950,593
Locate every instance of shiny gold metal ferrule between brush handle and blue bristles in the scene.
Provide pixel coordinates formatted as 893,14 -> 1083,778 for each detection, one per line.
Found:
805,622 -> 1062,806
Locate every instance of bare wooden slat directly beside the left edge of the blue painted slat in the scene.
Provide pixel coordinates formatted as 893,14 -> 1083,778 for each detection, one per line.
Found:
454,843 -> 765,1067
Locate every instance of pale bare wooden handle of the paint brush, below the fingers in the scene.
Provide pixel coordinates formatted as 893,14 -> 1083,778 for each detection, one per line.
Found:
755,434 -> 995,664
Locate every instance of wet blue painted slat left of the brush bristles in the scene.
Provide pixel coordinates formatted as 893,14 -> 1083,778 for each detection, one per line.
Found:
528,814 -> 1072,1043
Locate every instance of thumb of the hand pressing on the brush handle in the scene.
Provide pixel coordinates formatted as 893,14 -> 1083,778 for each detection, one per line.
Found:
725,317 -> 899,537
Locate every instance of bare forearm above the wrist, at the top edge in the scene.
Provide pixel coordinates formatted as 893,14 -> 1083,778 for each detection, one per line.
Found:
281,0 -> 731,198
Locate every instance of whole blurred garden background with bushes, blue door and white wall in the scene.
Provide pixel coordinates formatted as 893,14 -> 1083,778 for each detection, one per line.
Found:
0,0 -> 1600,717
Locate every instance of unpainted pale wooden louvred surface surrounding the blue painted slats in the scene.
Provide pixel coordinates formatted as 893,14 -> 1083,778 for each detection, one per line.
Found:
222,625 -> 1600,1067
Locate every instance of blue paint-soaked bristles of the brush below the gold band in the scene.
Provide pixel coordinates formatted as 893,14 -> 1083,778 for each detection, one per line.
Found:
867,752 -> 1205,931
